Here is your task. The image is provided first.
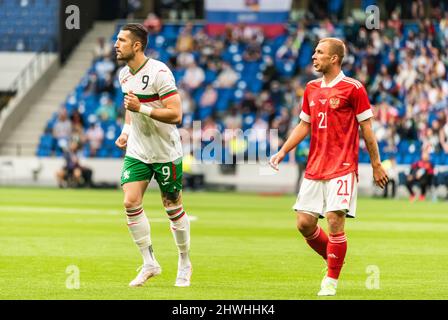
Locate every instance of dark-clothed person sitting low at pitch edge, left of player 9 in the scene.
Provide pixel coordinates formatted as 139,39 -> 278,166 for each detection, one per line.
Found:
56,141 -> 92,188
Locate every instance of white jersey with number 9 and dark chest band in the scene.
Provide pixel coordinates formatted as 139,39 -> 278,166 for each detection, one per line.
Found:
119,59 -> 182,163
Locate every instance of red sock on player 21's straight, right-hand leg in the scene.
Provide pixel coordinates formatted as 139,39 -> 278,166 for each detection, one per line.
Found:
327,232 -> 347,279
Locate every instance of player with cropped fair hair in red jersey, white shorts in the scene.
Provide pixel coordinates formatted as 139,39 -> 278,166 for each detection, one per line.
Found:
270,38 -> 388,296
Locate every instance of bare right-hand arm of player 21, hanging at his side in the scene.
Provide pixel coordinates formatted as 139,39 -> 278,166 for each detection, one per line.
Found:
359,118 -> 389,188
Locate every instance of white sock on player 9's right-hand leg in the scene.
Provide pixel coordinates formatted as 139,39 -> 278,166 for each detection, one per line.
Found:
166,206 -> 191,268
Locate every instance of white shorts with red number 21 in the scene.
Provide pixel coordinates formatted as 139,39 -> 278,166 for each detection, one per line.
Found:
293,172 -> 358,218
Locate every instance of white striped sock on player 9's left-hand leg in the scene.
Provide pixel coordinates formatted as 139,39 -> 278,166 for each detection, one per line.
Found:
126,206 -> 156,265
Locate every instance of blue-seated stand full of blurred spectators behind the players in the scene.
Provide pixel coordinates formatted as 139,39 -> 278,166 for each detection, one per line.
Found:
37,17 -> 448,171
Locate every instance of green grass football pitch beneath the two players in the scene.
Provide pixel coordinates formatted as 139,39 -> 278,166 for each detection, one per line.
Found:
0,188 -> 448,300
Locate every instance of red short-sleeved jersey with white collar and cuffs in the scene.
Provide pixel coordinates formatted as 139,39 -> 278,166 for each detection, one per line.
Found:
300,71 -> 373,180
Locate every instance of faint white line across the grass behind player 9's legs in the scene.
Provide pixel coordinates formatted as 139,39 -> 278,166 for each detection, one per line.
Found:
0,205 -> 198,222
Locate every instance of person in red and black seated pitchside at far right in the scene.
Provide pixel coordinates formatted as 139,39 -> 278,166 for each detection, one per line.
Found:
406,152 -> 434,201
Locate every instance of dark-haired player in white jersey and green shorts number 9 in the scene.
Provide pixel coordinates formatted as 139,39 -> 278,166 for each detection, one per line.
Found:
115,24 -> 192,287
